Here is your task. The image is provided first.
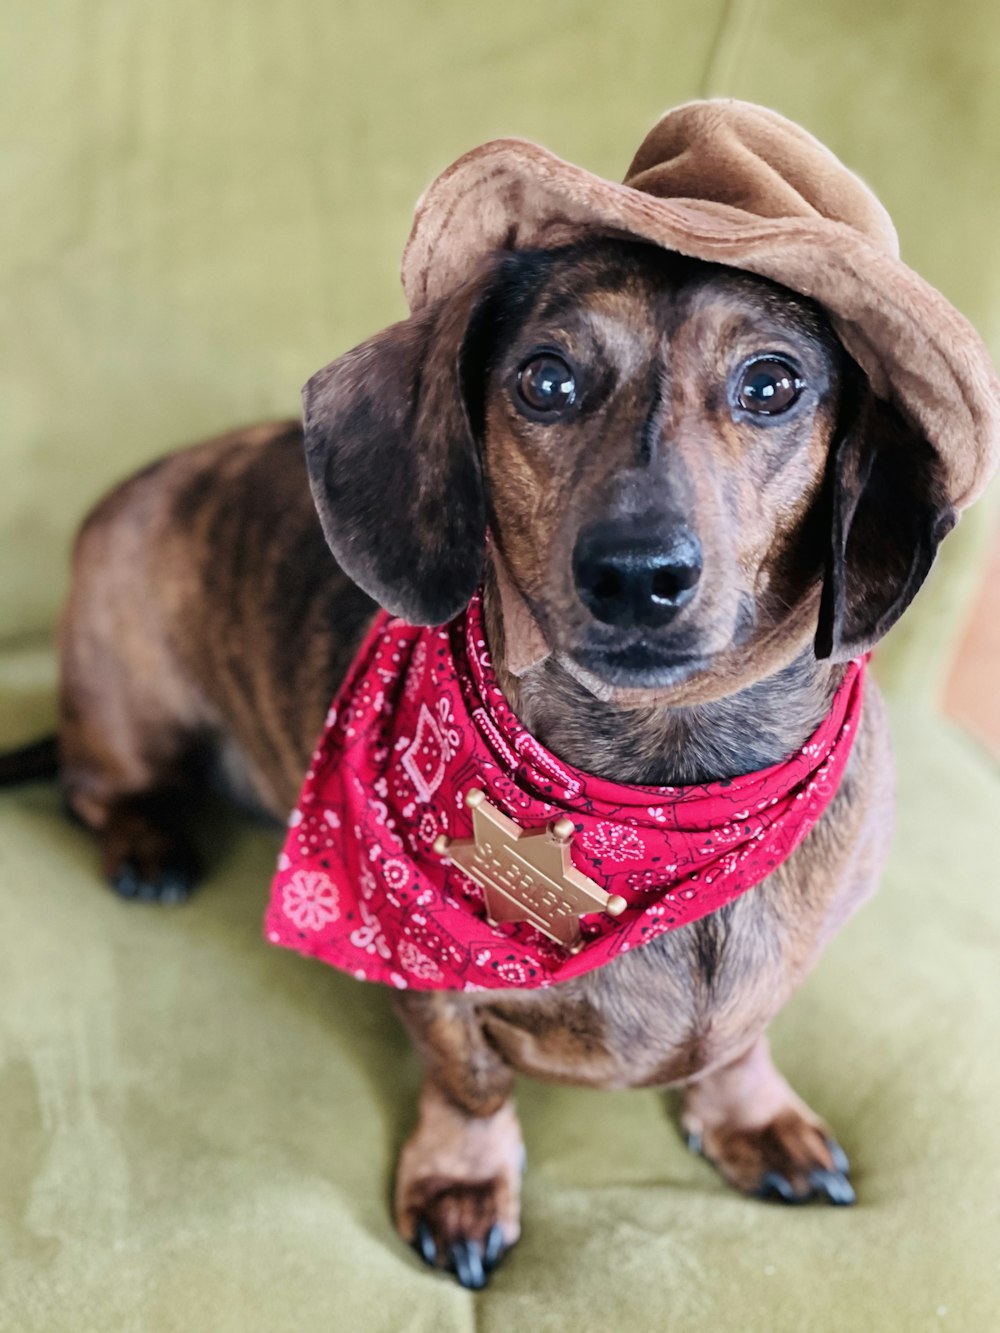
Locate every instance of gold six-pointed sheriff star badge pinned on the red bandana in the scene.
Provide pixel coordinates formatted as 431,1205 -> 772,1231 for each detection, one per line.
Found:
435,786 -> 628,952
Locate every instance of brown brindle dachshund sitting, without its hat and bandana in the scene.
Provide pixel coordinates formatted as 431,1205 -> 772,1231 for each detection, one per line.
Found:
17,239 -> 947,1286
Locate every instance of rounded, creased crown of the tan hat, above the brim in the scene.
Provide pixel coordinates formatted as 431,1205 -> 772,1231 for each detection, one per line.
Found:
624,99 -> 899,256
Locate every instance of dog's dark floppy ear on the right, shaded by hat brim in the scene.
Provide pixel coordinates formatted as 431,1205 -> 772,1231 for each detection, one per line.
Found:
816,381 -> 957,661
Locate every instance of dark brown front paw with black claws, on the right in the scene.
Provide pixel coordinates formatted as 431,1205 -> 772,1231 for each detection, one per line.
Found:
687,1106 -> 855,1205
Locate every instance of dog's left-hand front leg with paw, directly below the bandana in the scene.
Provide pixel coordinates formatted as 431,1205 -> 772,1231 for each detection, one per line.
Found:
395,993 -> 524,1288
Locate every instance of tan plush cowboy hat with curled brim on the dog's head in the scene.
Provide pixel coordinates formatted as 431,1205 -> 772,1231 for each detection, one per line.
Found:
403,100 -> 1000,508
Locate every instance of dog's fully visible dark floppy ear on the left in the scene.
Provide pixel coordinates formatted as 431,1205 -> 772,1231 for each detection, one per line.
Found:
303,269 -> 492,625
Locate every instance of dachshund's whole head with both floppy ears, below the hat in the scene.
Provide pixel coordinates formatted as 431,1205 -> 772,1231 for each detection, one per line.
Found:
305,240 -> 955,697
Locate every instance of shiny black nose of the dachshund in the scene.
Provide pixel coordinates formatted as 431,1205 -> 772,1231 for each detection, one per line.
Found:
573,524 -> 701,629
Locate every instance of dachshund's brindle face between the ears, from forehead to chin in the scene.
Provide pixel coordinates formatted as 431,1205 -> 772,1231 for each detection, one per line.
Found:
473,244 -> 844,688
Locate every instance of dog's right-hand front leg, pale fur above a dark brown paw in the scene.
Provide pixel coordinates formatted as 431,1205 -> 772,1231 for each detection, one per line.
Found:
681,1036 -> 855,1204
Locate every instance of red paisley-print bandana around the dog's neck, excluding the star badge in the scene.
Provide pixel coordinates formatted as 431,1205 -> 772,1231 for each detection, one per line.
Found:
265,596 -> 864,990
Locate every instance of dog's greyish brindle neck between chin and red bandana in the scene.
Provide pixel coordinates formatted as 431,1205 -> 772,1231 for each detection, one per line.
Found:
483,579 -> 843,786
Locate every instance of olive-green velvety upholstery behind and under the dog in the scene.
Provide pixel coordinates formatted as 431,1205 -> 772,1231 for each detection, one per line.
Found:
0,0 -> 1000,1333
